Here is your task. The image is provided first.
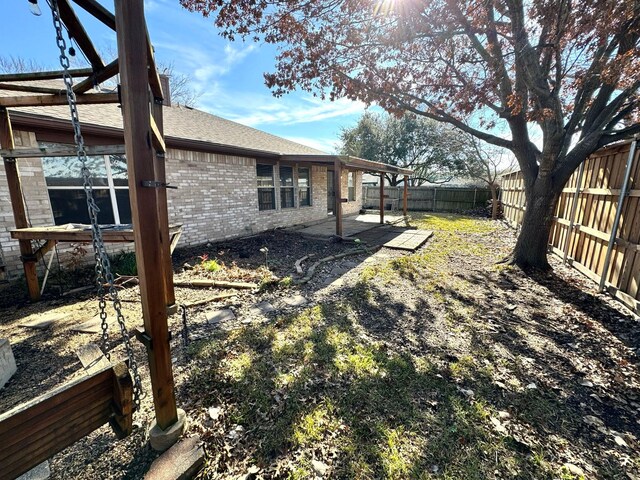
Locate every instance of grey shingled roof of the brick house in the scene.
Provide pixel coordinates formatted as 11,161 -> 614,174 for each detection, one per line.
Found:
0,80 -> 412,175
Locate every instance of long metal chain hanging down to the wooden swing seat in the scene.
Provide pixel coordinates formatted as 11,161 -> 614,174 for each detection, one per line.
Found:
50,0 -> 142,411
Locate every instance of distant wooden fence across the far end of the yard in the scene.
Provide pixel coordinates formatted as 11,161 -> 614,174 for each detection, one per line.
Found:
362,186 -> 491,212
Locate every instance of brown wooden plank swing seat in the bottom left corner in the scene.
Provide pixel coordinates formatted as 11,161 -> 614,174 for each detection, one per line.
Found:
0,346 -> 133,480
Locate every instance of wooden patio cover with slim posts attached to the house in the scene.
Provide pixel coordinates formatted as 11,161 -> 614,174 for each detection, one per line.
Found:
280,155 -> 413,237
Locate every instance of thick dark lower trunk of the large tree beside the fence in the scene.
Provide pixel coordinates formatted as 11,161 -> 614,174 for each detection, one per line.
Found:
509,178 -> 562,270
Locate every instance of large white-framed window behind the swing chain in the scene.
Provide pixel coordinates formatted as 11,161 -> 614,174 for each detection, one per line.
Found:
42,155 -> 131,225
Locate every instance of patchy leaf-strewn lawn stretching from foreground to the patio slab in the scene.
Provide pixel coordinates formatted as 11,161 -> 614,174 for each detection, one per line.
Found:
180,215 -> 640,479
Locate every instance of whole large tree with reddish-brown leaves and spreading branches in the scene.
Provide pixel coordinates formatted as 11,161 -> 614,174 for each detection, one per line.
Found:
180,0 -> 640,269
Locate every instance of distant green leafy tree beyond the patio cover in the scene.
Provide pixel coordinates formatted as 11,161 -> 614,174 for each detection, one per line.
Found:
340,111 -> 470,187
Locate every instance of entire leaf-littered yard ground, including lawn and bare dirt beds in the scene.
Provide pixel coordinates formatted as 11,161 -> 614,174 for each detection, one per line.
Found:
0,215 -> 640,479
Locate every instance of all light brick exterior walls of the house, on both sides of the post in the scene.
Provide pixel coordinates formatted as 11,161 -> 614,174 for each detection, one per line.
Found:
0,137 -> 362,278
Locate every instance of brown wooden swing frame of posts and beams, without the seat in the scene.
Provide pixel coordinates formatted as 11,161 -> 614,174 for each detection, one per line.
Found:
0,0 -> 184,468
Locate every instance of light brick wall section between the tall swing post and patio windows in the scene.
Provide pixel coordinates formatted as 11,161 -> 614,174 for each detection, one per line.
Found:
167,149 -> 327,245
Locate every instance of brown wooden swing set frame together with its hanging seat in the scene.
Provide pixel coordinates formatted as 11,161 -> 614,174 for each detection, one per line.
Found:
0,0 -> 178,479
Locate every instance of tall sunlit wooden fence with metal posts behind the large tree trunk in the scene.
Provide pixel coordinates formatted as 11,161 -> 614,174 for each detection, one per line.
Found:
501,140 -> 640,313
